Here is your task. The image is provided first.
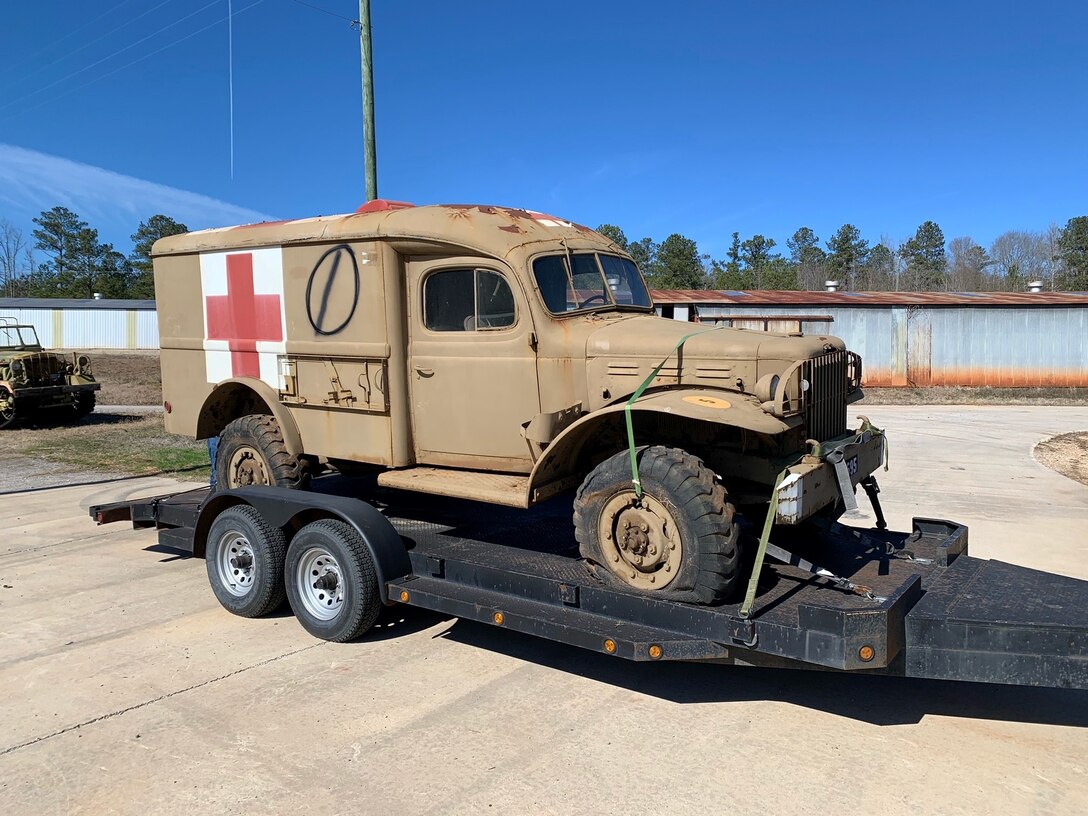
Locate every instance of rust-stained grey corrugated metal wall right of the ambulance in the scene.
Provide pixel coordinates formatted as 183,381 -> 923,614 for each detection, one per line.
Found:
697,304 -> 1088,387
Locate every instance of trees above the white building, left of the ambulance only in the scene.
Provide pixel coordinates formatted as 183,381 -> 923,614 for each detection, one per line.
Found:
0,207 -> 188,299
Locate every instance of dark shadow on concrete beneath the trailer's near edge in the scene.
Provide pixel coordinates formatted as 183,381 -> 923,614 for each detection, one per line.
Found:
433,616 -> 1088,728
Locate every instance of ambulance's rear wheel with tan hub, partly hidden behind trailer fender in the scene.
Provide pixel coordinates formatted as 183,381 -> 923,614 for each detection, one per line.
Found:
215,413 -> 310,490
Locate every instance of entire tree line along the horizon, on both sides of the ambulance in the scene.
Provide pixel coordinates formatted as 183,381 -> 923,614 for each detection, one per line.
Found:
0,207 -> 1088,298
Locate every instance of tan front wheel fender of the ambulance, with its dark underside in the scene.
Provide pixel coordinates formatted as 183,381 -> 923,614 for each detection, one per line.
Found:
529,388 -> 790,502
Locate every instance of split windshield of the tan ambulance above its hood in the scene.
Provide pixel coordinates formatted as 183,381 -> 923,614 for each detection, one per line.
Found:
533,252 -> 650,314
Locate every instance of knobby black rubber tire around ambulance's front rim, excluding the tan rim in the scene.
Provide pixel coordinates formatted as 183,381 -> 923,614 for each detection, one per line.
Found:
574,445 -> 740,604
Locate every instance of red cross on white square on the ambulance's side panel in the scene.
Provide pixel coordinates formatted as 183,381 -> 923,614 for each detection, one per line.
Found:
205,252 -> 283,378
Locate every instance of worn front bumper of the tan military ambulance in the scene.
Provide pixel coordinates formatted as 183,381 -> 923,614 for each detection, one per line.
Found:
775,426 -> 887,524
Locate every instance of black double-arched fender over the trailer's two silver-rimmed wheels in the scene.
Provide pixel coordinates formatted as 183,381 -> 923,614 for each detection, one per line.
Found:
193,485 -> 411,604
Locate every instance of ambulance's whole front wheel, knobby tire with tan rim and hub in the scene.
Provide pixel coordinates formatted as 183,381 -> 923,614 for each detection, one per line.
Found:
574,446 -> 740,604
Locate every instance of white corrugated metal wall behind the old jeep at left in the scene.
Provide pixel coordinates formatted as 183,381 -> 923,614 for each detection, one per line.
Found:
0,305 -> 159,349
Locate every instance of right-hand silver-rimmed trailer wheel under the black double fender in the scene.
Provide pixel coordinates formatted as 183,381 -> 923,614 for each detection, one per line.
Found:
286,519 -> 382,643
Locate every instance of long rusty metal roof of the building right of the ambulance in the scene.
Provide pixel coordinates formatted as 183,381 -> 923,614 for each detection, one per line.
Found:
653,289 -> 1088,307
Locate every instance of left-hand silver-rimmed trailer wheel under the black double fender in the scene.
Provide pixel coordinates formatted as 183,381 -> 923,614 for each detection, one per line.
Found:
205,505 -> 287,618
